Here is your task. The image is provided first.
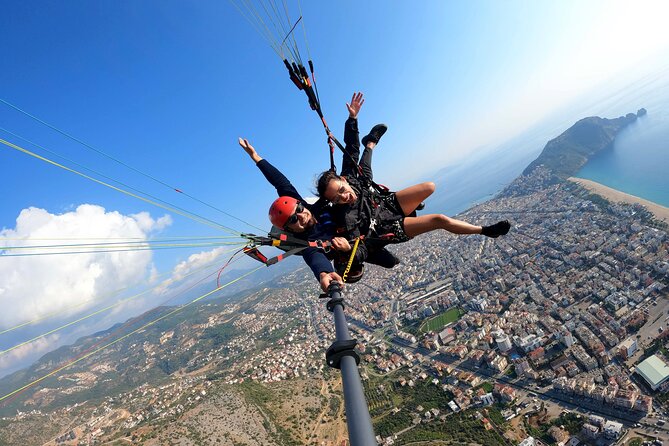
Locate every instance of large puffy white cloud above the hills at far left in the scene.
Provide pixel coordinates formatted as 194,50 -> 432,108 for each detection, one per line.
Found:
0,204 -> 171,327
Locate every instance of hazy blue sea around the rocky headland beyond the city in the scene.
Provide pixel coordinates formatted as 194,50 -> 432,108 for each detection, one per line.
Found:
425,63 -> 669,215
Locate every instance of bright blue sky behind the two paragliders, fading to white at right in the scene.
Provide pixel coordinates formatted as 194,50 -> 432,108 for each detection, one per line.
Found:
0,1 -> 669,373
